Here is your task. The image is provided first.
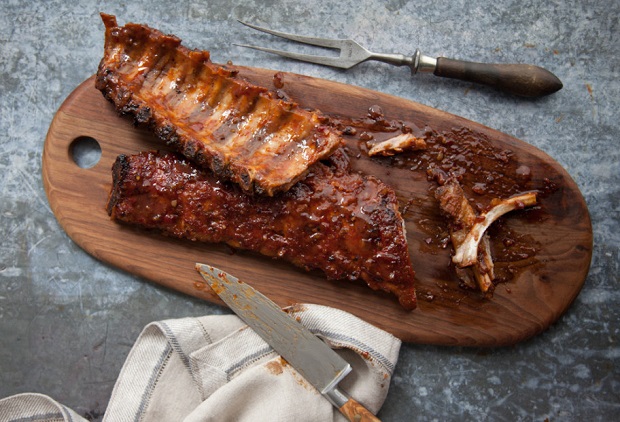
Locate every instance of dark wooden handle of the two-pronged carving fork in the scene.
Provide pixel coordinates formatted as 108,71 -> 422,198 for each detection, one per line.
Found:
433,57 -> 563,97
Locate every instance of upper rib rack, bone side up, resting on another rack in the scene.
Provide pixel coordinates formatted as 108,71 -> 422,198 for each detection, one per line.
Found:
96,14 -> 343,195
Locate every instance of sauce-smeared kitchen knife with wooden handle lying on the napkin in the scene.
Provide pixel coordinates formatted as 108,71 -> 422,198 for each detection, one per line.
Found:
196,263 -> 379,421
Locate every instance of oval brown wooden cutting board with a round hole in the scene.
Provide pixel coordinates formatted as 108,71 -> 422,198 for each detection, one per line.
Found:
43,73 -> 592,346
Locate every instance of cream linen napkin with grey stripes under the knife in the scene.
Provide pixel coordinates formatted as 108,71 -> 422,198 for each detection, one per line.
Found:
0,304 -> 401,422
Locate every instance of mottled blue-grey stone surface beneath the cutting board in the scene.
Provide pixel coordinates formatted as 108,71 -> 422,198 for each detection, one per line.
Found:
0,0 -> 620,421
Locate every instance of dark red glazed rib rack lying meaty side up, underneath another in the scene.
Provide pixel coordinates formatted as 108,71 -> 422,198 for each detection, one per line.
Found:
108,150 -> 416,309
